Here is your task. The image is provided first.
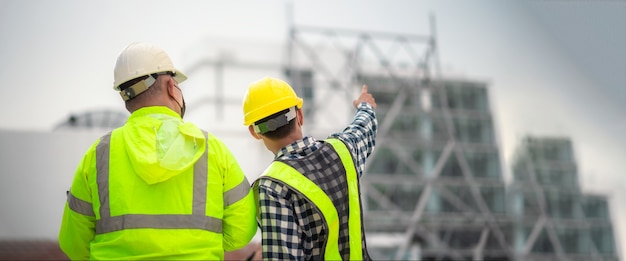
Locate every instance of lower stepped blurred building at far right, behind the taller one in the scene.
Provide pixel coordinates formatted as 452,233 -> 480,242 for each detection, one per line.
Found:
509,137 -> 619,261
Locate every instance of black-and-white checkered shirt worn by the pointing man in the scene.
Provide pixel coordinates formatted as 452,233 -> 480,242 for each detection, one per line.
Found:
258,103 -> 378,260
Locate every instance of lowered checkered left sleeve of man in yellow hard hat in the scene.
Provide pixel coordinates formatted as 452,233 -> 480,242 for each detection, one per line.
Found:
259,179 -> 304,260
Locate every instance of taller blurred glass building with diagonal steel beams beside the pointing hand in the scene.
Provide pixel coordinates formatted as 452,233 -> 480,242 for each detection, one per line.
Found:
357,75 -> 511,260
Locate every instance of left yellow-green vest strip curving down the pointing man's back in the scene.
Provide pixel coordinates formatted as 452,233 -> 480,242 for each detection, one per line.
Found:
263,161 -> 341,260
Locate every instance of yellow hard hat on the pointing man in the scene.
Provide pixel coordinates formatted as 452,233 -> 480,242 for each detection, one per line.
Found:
243,77 -> 302,126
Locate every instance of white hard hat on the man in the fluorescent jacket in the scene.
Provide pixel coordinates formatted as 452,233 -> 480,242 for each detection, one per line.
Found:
113,42 -> 187,91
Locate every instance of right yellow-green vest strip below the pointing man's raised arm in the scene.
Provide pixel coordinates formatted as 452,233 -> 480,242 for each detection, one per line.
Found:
326,139 -> 363,260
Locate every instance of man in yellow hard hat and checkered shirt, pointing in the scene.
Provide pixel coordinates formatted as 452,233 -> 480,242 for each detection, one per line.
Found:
243,77 -> 378,260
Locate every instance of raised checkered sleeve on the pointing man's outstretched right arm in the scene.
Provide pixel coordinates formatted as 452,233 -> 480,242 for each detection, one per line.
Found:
330,102 -> 378,176
